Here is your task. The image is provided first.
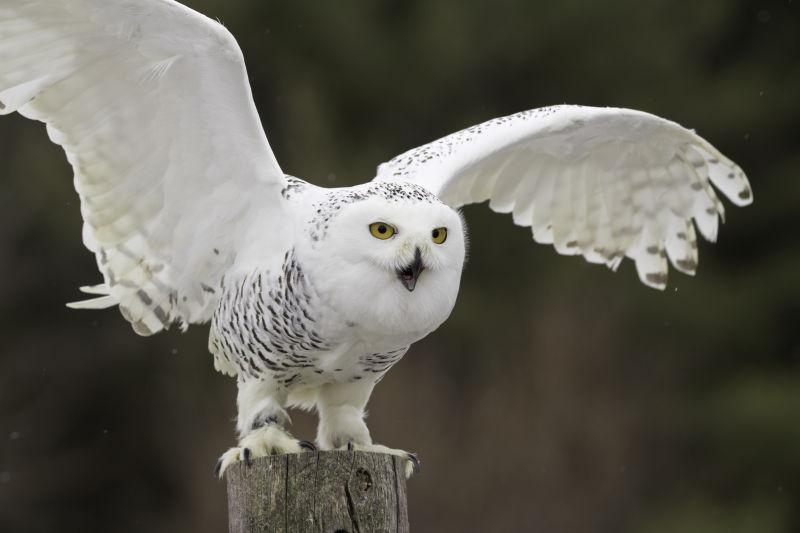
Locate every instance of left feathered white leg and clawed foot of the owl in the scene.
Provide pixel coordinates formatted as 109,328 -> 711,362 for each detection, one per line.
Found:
214,380 -> 314,478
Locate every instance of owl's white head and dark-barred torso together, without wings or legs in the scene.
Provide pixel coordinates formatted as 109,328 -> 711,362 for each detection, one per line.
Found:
209,176 -> 464,416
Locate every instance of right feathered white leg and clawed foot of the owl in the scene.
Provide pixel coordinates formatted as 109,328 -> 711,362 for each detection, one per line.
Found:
317,381 -> 420,478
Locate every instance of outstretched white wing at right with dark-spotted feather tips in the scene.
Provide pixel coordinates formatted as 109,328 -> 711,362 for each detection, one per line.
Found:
375,106 -> 753,289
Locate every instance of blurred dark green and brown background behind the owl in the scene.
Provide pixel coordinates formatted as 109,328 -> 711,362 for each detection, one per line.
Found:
0,0 -> 800,533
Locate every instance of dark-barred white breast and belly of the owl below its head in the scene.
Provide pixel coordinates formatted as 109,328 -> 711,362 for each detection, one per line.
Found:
209,250 -> 410,389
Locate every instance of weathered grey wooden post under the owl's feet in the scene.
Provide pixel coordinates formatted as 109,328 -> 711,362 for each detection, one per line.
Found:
225,451 -> 409,533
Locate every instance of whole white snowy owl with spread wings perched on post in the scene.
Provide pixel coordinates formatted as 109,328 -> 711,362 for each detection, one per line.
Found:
0,0 -> 753,475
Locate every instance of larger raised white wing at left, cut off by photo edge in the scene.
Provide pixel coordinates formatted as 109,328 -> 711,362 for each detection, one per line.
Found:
0,0 -> 284,335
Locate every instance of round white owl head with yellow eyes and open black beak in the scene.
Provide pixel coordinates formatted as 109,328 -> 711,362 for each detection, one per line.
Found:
314,182 -> 466,340
